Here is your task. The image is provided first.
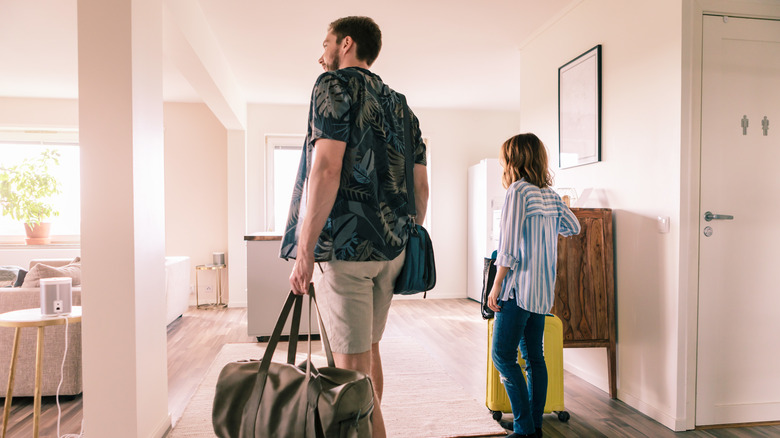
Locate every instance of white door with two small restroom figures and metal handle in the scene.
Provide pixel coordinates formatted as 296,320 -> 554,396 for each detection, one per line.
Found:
696,16 -> 780,425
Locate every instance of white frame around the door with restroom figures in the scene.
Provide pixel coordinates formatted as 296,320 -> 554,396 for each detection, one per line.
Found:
675,0 -> 780,430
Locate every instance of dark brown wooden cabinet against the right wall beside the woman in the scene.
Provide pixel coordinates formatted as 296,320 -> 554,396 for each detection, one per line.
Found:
551,208 -> 617,398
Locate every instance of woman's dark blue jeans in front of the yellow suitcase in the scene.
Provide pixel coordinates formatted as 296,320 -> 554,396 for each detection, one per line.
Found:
492,299 -> 547,435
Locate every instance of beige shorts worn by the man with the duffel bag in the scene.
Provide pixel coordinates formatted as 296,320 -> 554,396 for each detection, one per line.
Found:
313,252 -> 404,354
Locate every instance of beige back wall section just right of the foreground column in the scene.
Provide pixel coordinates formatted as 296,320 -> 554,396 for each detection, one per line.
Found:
163,103 -> 230,299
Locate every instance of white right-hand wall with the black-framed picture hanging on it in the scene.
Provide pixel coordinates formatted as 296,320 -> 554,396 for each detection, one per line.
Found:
520,0 -> 682,428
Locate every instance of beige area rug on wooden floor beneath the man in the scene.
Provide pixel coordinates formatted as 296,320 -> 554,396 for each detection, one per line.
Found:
169,337 -> 506,438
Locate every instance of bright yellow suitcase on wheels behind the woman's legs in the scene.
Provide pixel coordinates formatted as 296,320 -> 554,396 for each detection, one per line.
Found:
485,315 -> 570,422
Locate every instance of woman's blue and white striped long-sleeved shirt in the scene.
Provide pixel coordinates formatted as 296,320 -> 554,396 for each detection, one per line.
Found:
496,179 -> 580,314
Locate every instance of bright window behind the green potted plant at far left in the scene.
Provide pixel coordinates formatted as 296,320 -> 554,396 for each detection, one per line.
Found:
0,130 -> 81,244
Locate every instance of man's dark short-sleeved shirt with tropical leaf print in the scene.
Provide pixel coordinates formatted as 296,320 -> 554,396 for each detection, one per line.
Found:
280,67 -> 426,261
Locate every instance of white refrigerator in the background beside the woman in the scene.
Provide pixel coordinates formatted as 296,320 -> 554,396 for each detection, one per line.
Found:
467,158 -> 506,301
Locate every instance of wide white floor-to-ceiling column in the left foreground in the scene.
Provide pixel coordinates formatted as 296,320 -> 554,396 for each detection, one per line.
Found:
78,0 -> 171,438
